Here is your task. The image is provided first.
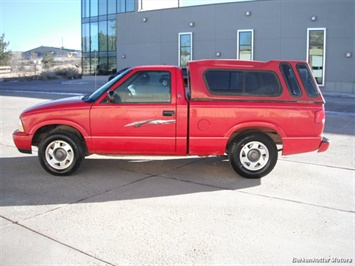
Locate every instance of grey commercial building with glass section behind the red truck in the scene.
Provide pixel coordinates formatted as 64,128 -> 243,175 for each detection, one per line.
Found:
82,0 -> 355,93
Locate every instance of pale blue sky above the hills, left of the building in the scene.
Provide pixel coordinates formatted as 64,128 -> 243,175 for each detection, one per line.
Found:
0,0 -> 81,52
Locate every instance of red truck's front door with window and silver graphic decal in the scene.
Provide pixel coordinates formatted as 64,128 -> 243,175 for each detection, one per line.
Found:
90,70 -> 176,155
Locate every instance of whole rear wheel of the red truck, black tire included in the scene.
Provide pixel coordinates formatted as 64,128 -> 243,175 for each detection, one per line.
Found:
229,131 -> 278,178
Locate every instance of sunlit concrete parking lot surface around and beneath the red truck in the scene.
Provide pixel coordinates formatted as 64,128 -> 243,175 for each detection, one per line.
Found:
0,80 -> 355,265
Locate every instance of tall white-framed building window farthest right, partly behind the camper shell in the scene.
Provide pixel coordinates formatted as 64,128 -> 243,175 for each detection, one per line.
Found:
307,28 -> 326,86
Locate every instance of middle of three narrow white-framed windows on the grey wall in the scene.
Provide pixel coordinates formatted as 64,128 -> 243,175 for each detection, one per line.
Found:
237,30 -> 254,60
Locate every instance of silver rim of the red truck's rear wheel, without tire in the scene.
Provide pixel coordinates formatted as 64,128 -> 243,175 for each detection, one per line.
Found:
239,141 -> 269,171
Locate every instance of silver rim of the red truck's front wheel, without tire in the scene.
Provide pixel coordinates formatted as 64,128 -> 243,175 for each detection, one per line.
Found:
45,140 -> 74,170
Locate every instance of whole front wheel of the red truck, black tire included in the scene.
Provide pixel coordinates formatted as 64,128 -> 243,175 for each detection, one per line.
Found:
38,131 -> 85,176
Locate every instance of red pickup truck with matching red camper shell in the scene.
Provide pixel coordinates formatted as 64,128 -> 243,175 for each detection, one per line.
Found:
13,60 -> 329,178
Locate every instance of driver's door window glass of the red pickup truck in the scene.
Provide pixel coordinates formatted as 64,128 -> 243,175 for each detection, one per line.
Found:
111,71 -> 171,103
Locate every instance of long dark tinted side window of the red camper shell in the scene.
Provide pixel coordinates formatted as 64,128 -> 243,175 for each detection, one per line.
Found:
204,70 -> 281,96
